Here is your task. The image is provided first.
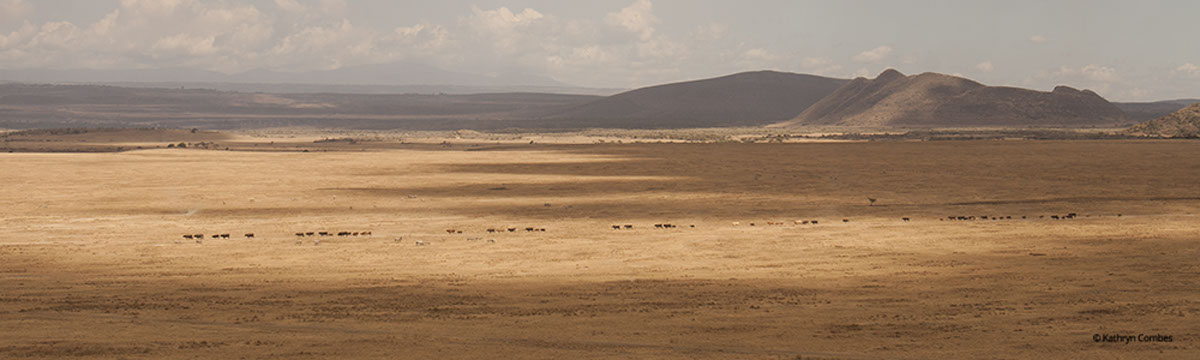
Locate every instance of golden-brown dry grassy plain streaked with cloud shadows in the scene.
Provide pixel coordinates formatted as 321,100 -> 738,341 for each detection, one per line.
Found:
0,142 -> 1200,359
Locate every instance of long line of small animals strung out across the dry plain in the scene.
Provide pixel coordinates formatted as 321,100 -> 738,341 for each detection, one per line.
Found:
175,212 -> 1121,246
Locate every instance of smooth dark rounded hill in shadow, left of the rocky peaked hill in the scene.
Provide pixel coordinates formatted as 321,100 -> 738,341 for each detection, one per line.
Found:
546,71 -> 847,128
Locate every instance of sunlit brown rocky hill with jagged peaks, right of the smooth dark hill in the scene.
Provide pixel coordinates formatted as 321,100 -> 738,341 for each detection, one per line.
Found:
776,68 -> 1124,127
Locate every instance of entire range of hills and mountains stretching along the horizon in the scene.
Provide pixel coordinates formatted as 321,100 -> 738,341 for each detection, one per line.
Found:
0,65 -> 1190,130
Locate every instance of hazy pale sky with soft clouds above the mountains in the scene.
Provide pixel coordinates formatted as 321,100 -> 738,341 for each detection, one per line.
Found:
0,0 -> 1200,101
